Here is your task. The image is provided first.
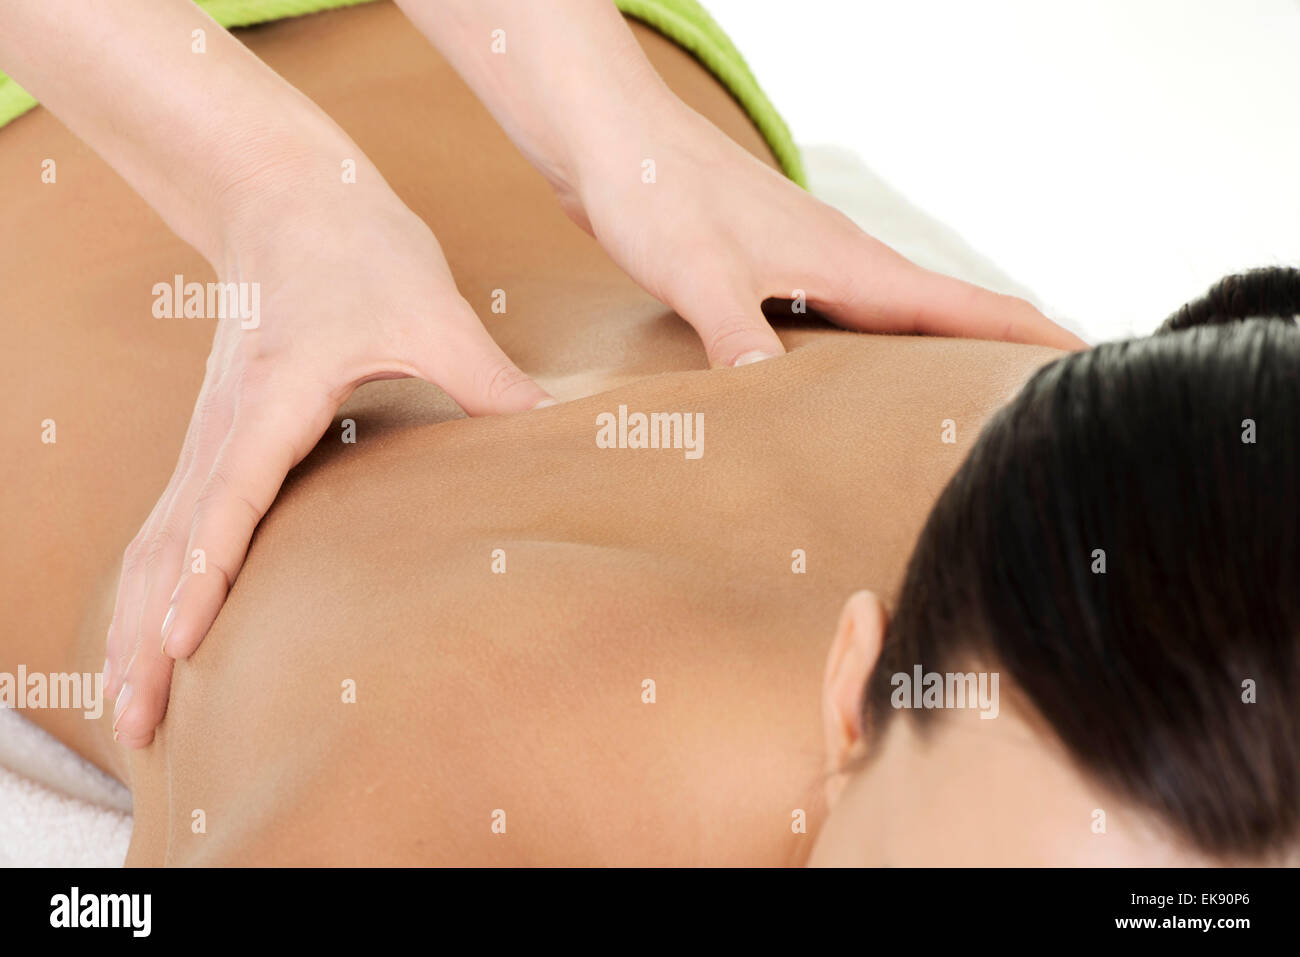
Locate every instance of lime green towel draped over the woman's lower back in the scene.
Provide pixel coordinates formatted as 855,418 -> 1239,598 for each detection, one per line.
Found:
0,0 -> 807,187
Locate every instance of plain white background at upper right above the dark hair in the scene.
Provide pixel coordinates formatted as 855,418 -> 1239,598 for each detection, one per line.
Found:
705,0 -> 1300,341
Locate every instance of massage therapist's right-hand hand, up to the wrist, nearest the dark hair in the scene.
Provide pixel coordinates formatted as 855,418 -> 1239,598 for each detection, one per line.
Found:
559,95 -> 1084,367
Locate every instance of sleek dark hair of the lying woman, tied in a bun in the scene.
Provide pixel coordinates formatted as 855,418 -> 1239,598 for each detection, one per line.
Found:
865,269 -> 1300,858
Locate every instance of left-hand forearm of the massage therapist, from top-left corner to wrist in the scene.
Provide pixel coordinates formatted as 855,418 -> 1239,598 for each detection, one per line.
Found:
0,0 -> 378,272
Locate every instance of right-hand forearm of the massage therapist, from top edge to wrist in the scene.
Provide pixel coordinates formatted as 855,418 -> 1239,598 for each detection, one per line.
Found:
397,0 -> 677,196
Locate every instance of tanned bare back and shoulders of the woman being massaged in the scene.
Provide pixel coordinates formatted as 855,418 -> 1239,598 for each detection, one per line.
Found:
0,5 -> 1056,865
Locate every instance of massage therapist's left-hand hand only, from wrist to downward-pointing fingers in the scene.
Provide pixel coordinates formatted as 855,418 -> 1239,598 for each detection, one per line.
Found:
108,187 -> 549,746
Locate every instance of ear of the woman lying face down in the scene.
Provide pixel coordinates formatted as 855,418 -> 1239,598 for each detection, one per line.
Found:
822,592 -> 888,801
